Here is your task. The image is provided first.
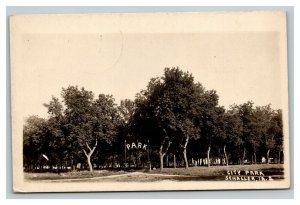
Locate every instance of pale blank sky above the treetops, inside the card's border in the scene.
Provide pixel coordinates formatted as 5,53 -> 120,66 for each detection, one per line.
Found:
22,32 -> 281,117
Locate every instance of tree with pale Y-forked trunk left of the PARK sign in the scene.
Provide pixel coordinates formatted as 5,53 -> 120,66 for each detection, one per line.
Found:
62,86 -> 119,173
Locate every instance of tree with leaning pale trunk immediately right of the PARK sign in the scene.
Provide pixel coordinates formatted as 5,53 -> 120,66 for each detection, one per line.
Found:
132,78 -> 174,171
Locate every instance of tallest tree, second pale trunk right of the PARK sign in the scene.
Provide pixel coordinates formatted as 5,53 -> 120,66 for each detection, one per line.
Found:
161,68 -> 204,168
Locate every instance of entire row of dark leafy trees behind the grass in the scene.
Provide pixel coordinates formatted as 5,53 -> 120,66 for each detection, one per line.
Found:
23,68 -> 283,172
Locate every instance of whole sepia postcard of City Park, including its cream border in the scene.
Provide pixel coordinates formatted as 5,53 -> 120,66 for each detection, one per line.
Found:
9,11 -> 290,192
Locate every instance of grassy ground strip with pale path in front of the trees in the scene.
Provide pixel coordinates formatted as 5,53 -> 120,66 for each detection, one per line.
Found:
24,164 -> 284,182
